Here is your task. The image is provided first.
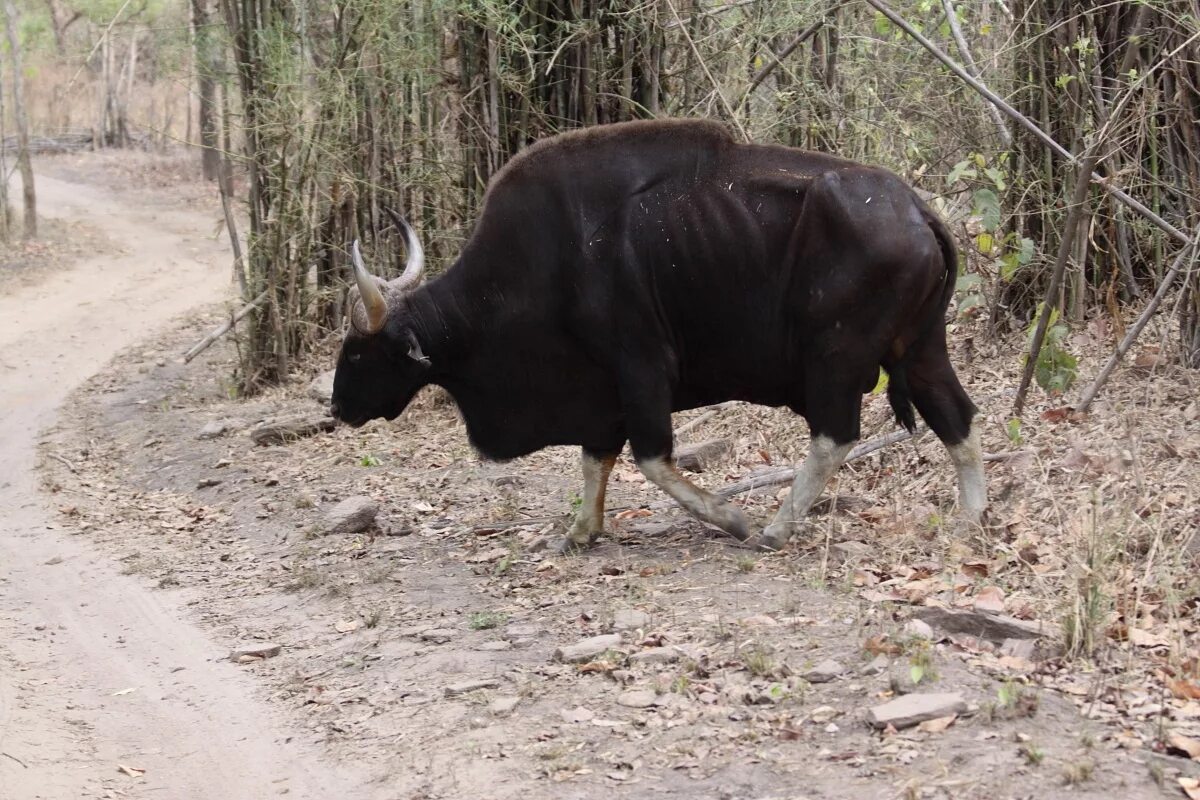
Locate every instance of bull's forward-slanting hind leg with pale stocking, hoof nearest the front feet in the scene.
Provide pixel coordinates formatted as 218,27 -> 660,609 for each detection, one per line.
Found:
755,363 -> 863,551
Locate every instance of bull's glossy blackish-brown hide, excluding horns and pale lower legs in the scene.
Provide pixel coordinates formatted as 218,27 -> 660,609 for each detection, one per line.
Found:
334,121 -> 974,461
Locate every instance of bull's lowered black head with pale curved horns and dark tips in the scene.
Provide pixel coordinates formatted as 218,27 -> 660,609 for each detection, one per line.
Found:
329,209 -> 430,427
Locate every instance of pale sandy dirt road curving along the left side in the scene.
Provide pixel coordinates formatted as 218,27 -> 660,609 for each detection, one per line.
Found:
0,176 -> 361,800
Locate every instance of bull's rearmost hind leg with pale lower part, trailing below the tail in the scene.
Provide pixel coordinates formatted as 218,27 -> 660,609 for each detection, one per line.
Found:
907,326 -> 988,525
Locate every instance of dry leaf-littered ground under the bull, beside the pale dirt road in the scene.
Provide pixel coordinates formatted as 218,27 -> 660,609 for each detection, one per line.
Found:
14,159 -> 1200,799
